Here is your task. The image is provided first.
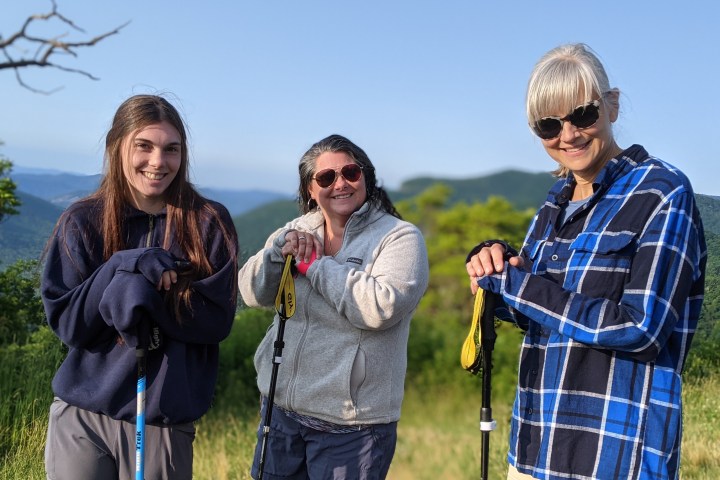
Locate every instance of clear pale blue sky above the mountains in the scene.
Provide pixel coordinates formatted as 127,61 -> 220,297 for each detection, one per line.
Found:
0,0 -> 720,195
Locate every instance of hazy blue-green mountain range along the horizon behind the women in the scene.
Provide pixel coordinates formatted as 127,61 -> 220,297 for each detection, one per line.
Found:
0,169 -> 720,269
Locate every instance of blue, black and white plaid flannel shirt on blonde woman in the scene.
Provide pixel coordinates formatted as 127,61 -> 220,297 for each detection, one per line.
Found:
479,145 -> 707,480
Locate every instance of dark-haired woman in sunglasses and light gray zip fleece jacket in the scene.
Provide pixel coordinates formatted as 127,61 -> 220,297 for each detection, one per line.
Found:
239,135 -> 428,480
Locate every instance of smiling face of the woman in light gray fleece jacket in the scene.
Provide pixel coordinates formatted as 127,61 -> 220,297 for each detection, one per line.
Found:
308,152 -> 367,225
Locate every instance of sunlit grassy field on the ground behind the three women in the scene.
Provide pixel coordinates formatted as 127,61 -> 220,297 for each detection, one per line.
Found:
0,333 -> 720,480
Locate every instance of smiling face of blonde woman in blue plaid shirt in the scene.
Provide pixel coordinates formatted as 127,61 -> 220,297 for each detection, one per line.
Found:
541,91 -> 619,183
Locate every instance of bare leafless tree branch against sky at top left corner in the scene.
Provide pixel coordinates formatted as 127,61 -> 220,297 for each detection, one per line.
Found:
0,0 -> 130,94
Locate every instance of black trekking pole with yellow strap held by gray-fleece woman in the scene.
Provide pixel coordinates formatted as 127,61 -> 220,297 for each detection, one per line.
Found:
258,255 -> 295,480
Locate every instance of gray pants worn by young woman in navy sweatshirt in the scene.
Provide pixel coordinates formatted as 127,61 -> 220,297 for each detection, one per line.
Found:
45,398 -> 195,480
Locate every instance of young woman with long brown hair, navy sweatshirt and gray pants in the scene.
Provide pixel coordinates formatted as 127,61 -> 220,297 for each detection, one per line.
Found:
42,95 -> 238,479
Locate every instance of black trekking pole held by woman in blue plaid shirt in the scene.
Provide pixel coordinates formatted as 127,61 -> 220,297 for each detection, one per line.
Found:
478,290 -> 497,480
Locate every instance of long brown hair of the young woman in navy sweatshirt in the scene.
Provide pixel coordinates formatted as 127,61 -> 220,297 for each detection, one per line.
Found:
88,95 -> 237,321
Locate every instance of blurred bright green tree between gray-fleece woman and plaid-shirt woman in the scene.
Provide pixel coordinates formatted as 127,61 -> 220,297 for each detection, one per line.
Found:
396,184 -> 534,396
